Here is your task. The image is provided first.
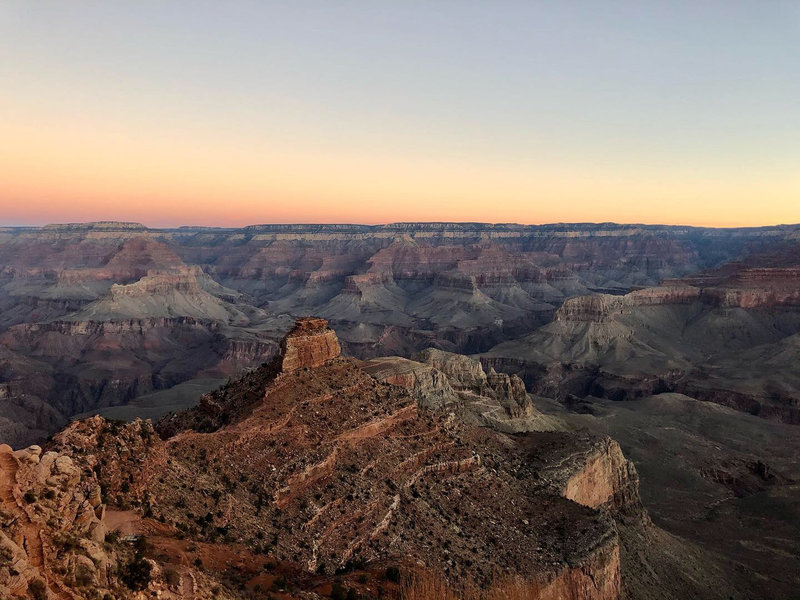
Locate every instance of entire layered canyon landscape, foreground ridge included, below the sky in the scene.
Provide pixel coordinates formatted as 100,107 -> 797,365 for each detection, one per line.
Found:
0,223 -> 800,599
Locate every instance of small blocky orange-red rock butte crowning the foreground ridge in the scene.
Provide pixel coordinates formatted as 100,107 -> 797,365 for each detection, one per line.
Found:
280,317 -> 341,373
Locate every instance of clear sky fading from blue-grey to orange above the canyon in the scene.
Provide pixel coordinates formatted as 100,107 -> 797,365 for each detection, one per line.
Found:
0,0 -> 800,226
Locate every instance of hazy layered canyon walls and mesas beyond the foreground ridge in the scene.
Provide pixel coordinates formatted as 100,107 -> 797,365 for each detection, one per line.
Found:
0,223 -> 800,446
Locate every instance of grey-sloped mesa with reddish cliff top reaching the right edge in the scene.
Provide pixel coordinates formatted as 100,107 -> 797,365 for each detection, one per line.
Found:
482,268 -> 800,424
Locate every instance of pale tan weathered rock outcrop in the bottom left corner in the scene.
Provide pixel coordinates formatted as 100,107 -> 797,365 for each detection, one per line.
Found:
0,444 -> 116,599
